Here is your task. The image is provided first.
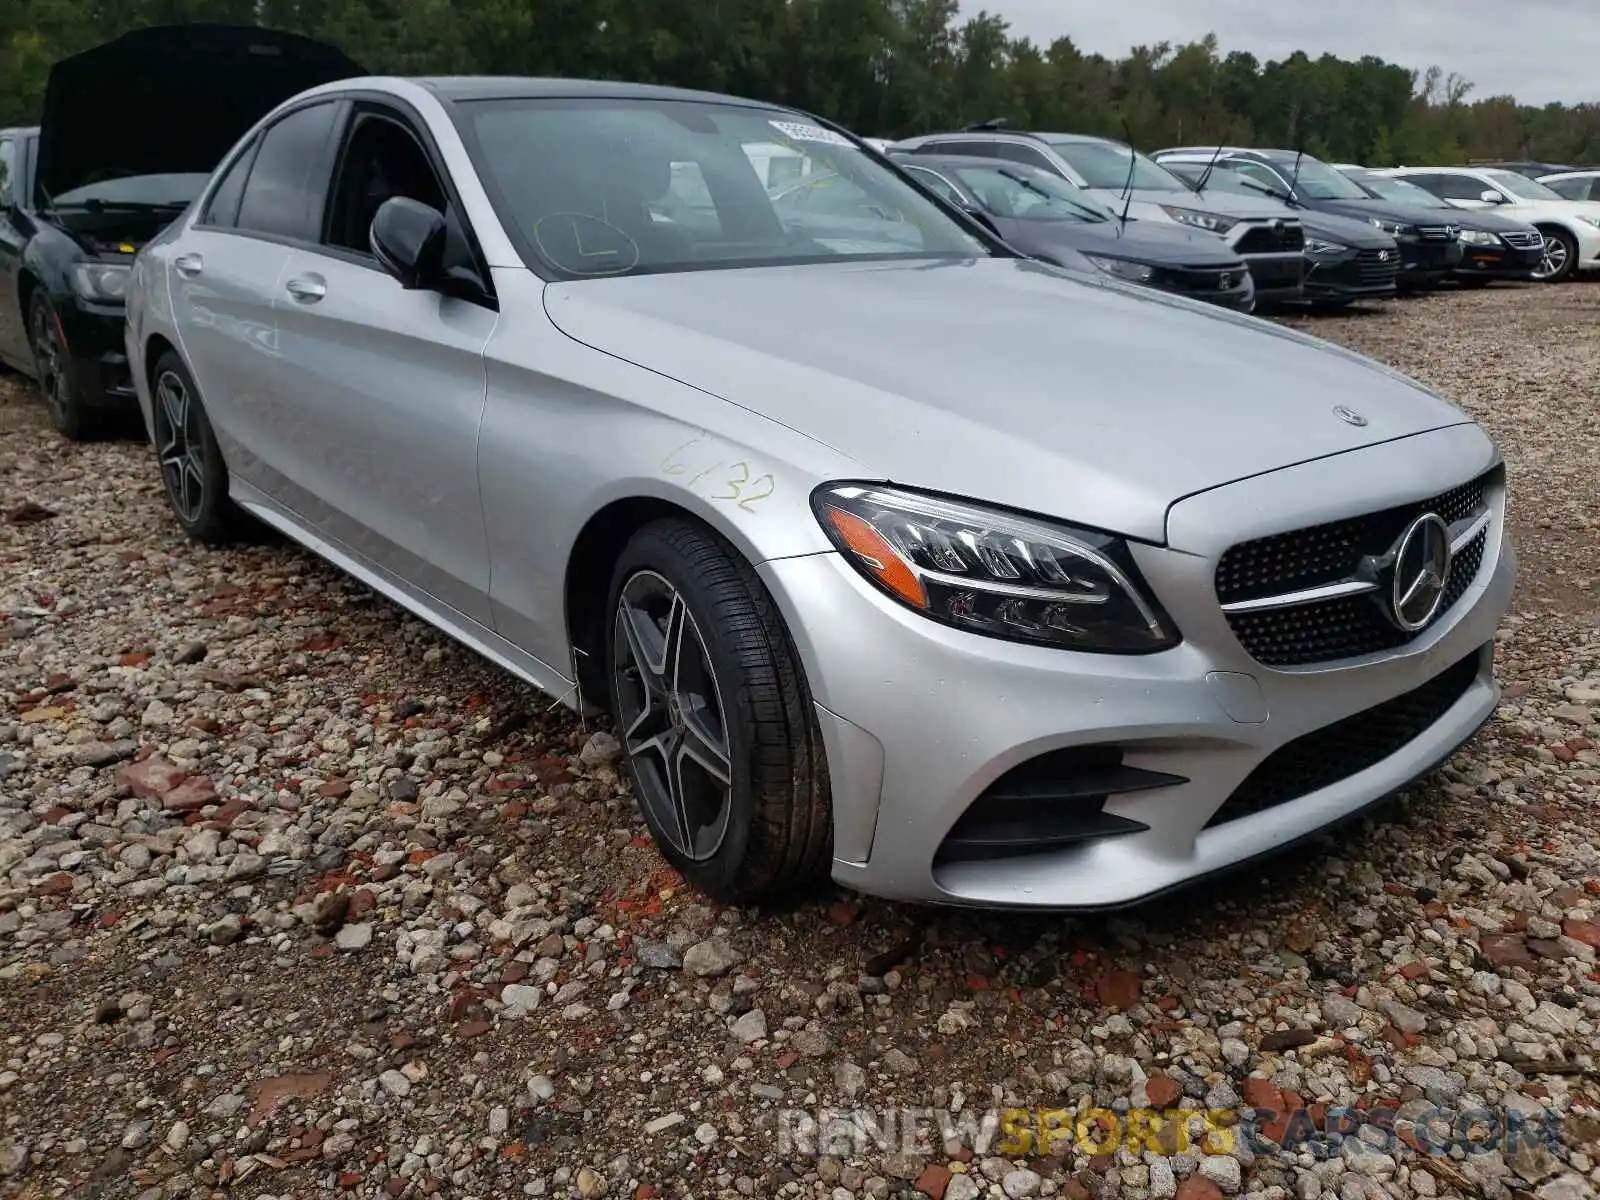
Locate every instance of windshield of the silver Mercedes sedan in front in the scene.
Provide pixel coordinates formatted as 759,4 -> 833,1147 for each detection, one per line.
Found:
461,98 -> 990,278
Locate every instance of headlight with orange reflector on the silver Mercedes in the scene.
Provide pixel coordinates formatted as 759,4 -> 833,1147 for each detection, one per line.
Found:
811,483 -> 1178,654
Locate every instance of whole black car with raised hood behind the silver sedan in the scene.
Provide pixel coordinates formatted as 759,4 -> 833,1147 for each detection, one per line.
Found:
0,24 -> 366,437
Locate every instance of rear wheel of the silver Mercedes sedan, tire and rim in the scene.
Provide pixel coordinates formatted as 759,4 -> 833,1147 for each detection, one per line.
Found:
150,350 -> 243,546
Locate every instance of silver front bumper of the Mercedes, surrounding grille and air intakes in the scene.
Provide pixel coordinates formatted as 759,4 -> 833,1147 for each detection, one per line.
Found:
760,426 -> 1515,909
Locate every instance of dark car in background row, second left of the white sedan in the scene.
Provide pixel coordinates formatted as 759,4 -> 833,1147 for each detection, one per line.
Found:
1152,146 -> 1461,288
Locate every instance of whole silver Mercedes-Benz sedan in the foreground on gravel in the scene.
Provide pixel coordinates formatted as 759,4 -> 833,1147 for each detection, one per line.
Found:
126,78 -> 1514,909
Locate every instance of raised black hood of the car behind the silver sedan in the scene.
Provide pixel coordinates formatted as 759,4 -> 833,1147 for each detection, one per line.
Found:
35,24 -> 368,198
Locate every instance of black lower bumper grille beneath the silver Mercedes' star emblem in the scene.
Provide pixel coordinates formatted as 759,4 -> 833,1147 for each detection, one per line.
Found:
1206,651 -> 1478,829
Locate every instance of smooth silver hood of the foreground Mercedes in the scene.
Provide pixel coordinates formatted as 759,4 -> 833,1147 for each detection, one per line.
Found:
544,259 -> 1467,541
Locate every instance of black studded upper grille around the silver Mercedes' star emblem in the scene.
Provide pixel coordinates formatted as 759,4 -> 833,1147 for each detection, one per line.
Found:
1216,467 -> 1499,667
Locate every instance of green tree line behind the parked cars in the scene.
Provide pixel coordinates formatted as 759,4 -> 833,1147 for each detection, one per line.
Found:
0,0 -> 1600,166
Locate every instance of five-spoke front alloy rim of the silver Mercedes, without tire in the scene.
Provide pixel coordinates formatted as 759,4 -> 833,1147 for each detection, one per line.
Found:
611,571 -> 733,862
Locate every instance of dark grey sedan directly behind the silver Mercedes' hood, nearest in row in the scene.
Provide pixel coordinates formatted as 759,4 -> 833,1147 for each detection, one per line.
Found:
896,154 -> 1256,312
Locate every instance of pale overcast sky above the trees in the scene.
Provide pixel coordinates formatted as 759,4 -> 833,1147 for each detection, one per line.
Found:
985,0 -> 1600,104
